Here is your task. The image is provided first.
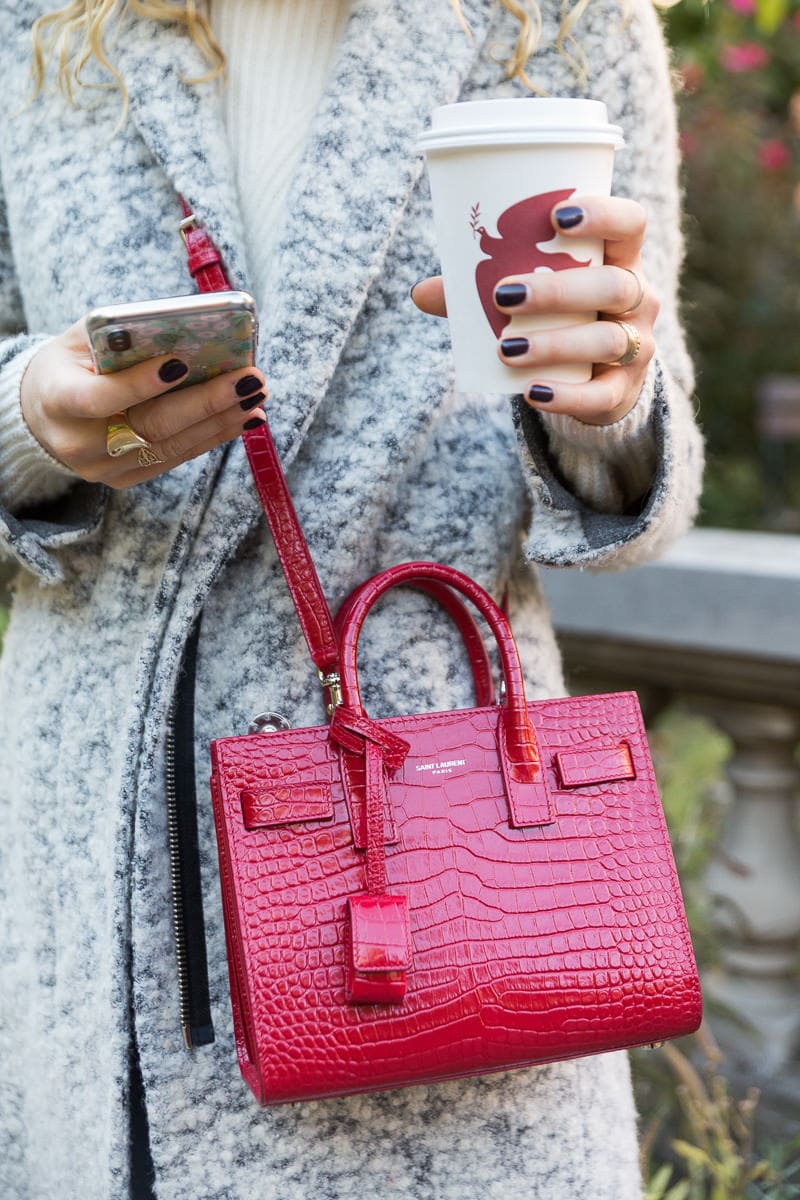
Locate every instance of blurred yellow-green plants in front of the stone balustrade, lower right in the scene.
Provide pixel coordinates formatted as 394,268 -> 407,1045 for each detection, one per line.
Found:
631,706 -> 800,1200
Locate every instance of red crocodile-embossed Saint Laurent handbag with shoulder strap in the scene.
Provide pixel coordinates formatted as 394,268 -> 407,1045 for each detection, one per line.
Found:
181,201 -> 700,1104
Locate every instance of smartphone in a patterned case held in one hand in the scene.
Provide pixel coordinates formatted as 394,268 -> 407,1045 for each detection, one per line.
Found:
86,292 -> 258,391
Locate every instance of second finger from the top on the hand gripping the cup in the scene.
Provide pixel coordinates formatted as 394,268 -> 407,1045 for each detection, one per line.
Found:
494,266 -> 658,319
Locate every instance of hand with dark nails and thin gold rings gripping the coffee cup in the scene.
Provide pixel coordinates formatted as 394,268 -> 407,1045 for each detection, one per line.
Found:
411,196 -> 660,425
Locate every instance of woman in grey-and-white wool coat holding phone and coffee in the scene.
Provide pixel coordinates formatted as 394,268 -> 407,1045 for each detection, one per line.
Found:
0,0 -> 700,1200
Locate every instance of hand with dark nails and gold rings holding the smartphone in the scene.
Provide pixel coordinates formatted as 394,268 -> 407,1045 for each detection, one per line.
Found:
20,319 -> 267,488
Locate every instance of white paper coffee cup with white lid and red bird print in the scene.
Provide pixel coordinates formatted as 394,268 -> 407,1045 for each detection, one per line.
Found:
417,97 -> 625,392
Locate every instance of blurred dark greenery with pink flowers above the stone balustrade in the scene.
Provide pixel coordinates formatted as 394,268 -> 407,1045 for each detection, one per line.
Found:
664,0 -> 800,529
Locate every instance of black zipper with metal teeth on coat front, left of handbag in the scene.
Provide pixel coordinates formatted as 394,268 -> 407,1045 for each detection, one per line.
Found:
164,618 -> 213,1050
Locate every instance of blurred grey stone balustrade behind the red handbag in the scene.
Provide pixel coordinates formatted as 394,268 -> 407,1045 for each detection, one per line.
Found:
541,529 -> 800,1115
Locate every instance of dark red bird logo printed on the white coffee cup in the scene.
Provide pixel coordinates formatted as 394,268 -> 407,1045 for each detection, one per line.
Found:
470,187 -> 590,337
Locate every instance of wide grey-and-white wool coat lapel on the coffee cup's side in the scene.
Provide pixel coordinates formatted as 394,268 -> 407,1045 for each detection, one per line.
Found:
200,0 -> 492,557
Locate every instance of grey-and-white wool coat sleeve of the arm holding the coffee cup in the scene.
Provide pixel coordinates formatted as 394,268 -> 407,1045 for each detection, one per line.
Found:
515,0 -> 703,569
